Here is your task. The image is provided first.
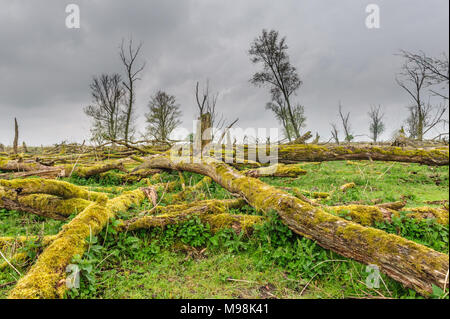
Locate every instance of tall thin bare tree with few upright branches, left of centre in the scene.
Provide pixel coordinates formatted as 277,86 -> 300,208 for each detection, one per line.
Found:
119,38 -> 145,142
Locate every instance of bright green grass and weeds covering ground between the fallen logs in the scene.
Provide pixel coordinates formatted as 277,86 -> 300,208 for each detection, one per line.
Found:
0,161 -> 449,298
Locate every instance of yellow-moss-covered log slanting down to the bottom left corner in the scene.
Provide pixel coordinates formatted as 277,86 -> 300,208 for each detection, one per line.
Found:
8,189 -> 151,299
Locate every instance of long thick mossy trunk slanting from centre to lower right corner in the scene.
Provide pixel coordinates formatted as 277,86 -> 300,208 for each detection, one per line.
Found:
140,156 -> 449,294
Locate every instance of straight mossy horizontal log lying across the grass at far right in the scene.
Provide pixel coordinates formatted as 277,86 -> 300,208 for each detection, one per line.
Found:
272,144 -> 449,165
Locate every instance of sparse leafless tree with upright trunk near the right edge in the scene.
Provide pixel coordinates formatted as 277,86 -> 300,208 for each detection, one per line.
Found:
396,51 -> 447,141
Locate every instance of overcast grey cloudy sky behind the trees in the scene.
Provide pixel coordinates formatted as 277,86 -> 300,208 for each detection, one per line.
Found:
0,0 -> 449,145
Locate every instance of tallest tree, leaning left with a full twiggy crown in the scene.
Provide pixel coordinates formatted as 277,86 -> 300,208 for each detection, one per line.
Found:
249,30 -> 302,138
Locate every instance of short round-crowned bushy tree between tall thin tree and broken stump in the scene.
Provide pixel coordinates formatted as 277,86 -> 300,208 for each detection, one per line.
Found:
146,91 -> 181,142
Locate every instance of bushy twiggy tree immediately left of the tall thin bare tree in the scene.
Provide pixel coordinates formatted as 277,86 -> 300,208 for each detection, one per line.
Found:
84,73 -> 126,141
